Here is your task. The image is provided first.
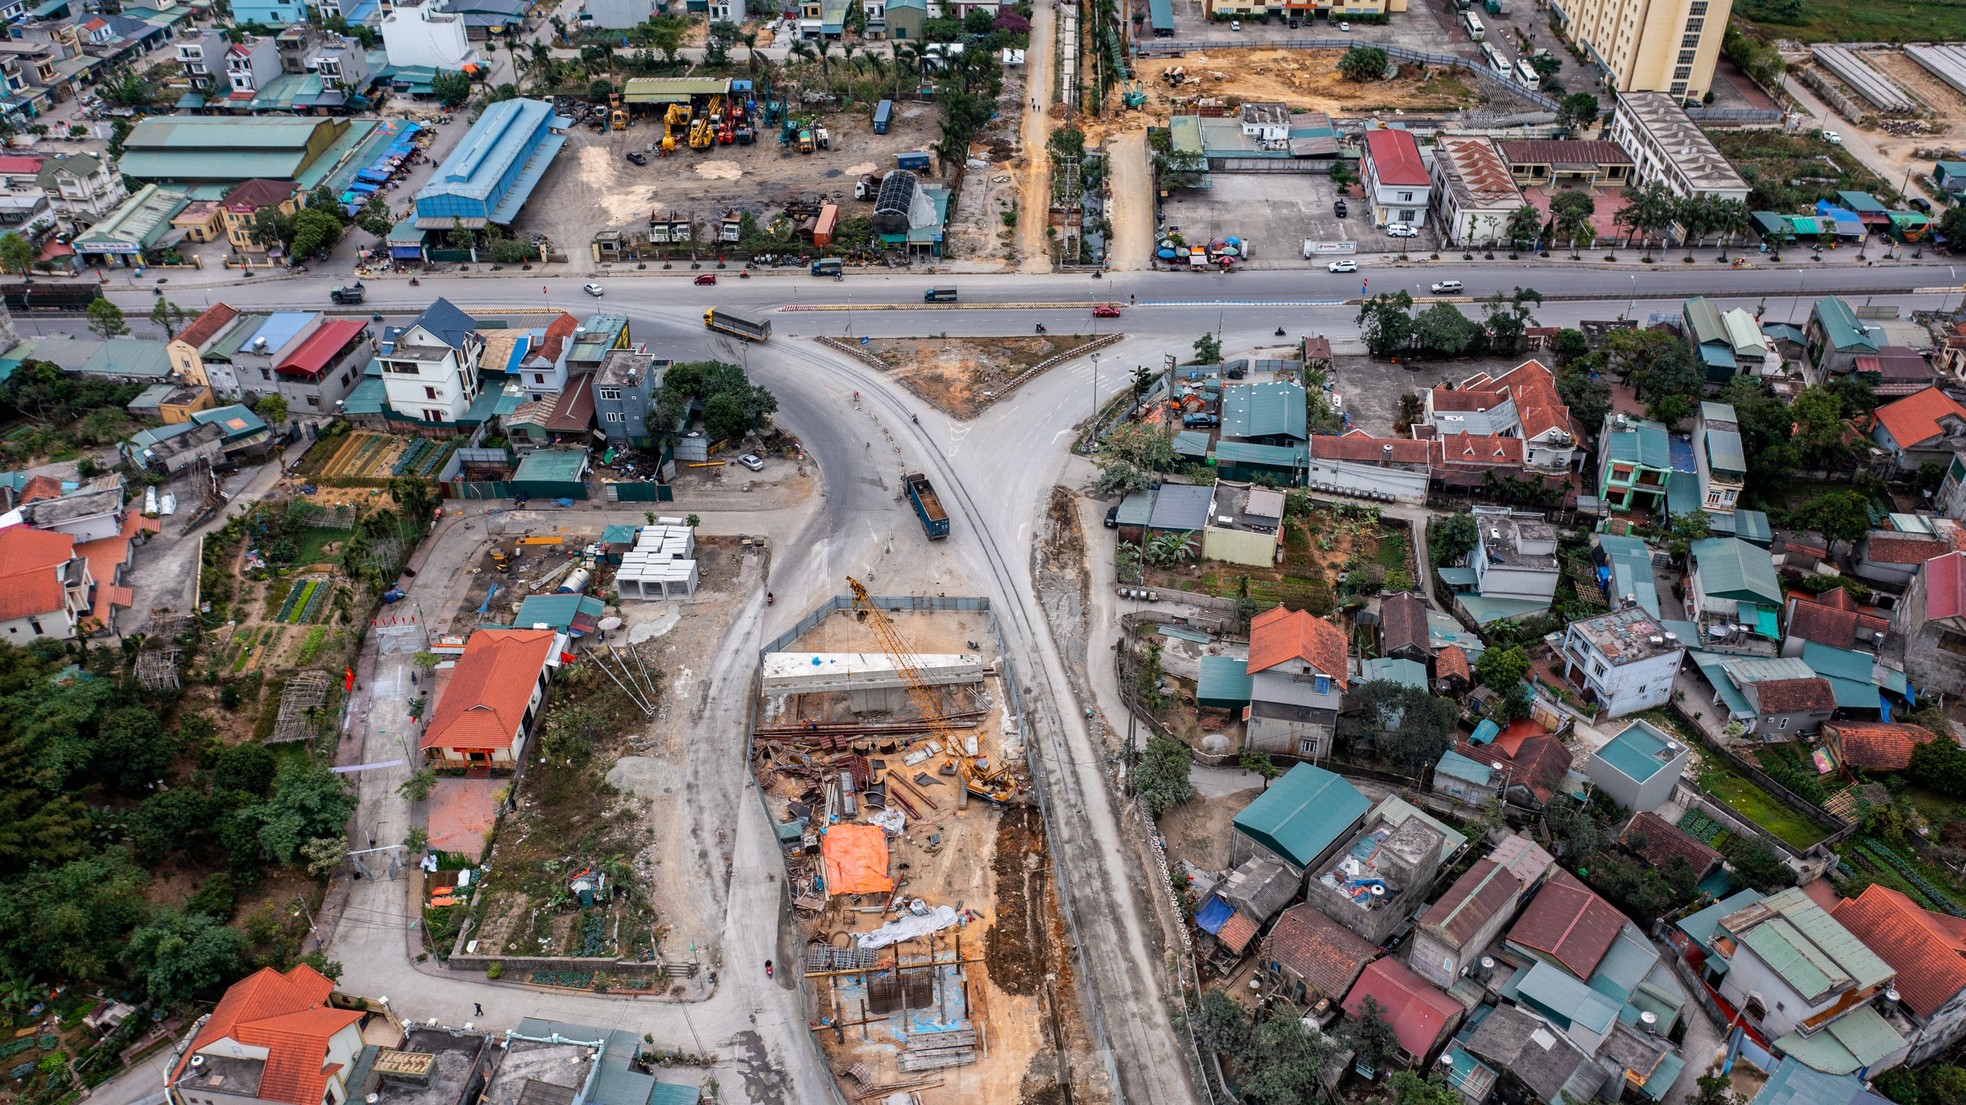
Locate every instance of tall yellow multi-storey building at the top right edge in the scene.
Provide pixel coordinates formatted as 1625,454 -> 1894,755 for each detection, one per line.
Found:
1549,0 -> 1734,100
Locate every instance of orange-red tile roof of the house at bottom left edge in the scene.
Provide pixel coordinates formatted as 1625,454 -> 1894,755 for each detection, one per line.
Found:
171,963 -> 364,1105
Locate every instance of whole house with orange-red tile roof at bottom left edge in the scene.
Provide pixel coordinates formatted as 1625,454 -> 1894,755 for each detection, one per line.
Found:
165,963 -> 368,1105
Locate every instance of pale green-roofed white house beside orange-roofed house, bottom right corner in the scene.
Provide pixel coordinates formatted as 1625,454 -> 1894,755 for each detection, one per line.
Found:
1712,887 -> 1909,1076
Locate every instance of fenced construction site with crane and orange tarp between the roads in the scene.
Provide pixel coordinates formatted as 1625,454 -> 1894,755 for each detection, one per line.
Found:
751,580 -> 1077,1105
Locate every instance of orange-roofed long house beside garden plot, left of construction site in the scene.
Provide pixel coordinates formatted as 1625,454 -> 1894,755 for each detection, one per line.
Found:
417,629 -> 562,769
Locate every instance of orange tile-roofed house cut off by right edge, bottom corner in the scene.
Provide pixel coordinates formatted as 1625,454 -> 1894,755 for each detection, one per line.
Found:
1830,883 -> 1966,1066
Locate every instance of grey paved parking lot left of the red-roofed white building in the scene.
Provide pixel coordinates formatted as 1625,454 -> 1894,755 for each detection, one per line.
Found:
1162,173 -> 1431,273
